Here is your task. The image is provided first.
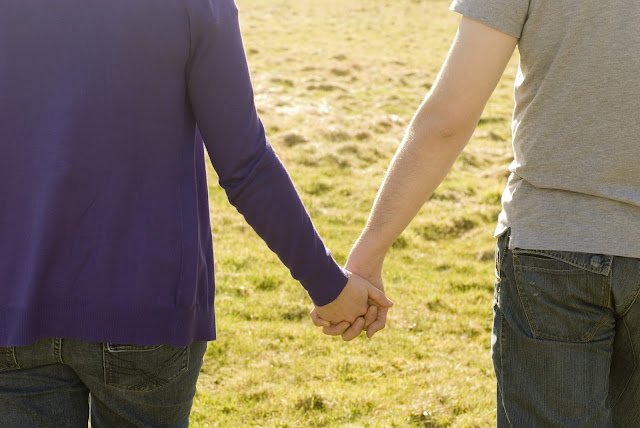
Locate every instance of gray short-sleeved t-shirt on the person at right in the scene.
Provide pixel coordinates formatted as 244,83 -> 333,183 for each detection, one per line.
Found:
451,0 -> 640,258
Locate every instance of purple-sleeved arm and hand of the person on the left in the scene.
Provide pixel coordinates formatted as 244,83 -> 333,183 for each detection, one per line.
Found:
187,0 -> 390,323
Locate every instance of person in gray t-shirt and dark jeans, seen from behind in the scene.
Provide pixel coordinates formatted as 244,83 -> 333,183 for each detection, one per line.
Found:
312,0 -> 640,427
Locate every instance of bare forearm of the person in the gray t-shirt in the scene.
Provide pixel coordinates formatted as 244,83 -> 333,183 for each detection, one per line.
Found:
346,17 -> 517,337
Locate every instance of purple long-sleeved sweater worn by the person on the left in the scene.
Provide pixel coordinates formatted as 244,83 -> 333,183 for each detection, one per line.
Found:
0,0 -> 346,346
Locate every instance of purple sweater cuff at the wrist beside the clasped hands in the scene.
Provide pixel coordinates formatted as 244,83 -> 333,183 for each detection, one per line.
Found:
300,254 -> 349,306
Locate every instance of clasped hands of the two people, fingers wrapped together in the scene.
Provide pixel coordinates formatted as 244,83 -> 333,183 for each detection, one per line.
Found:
311,274 -> 393,341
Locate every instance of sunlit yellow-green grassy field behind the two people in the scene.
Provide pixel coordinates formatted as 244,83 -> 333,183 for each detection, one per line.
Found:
191,0 -> 517,428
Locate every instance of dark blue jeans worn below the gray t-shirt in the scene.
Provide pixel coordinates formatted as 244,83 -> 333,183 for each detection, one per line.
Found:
491,233 -> 640,428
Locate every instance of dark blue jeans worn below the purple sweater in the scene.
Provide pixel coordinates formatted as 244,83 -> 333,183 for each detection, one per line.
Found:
0,339 -> 207,428
